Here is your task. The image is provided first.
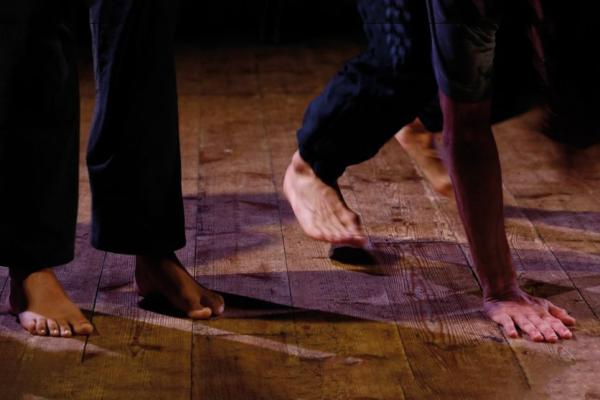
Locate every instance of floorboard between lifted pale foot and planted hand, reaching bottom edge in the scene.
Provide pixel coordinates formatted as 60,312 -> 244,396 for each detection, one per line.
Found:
344,138 -> 529,399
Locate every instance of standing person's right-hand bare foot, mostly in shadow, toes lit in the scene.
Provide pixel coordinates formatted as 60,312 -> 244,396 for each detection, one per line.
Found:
135,254 -> 225,319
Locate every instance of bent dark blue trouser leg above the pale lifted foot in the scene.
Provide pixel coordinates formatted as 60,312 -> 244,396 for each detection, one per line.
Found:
298,0 -> 436,182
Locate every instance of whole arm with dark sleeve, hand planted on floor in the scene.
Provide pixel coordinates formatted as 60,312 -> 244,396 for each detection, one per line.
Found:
428,0 -> 574,342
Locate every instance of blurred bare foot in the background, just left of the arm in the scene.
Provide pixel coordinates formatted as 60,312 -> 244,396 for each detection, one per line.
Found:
396,118 -> 453,197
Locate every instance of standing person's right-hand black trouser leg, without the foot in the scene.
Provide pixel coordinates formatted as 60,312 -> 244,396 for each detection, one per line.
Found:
87,0 -> 185,254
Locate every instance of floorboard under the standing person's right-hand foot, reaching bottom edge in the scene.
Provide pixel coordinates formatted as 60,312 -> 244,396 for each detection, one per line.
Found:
78,230 -> 195,399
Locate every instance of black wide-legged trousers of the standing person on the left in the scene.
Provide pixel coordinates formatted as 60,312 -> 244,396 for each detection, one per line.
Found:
0,0 -> 185,273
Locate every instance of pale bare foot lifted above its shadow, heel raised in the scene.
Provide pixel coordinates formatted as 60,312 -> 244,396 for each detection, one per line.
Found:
283,152 -> 367,247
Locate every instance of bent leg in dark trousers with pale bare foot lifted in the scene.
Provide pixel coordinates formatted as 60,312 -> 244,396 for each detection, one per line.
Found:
284,0 -> 435,245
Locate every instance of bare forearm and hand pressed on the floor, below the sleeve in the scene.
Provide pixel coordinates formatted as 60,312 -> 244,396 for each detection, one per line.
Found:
441,95 -> 575,342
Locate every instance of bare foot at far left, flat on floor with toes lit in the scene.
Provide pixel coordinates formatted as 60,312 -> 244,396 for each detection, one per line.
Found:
10,268 -> 94,337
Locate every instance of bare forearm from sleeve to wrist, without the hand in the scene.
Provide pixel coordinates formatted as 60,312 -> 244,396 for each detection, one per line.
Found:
442,96 -> 517,297
